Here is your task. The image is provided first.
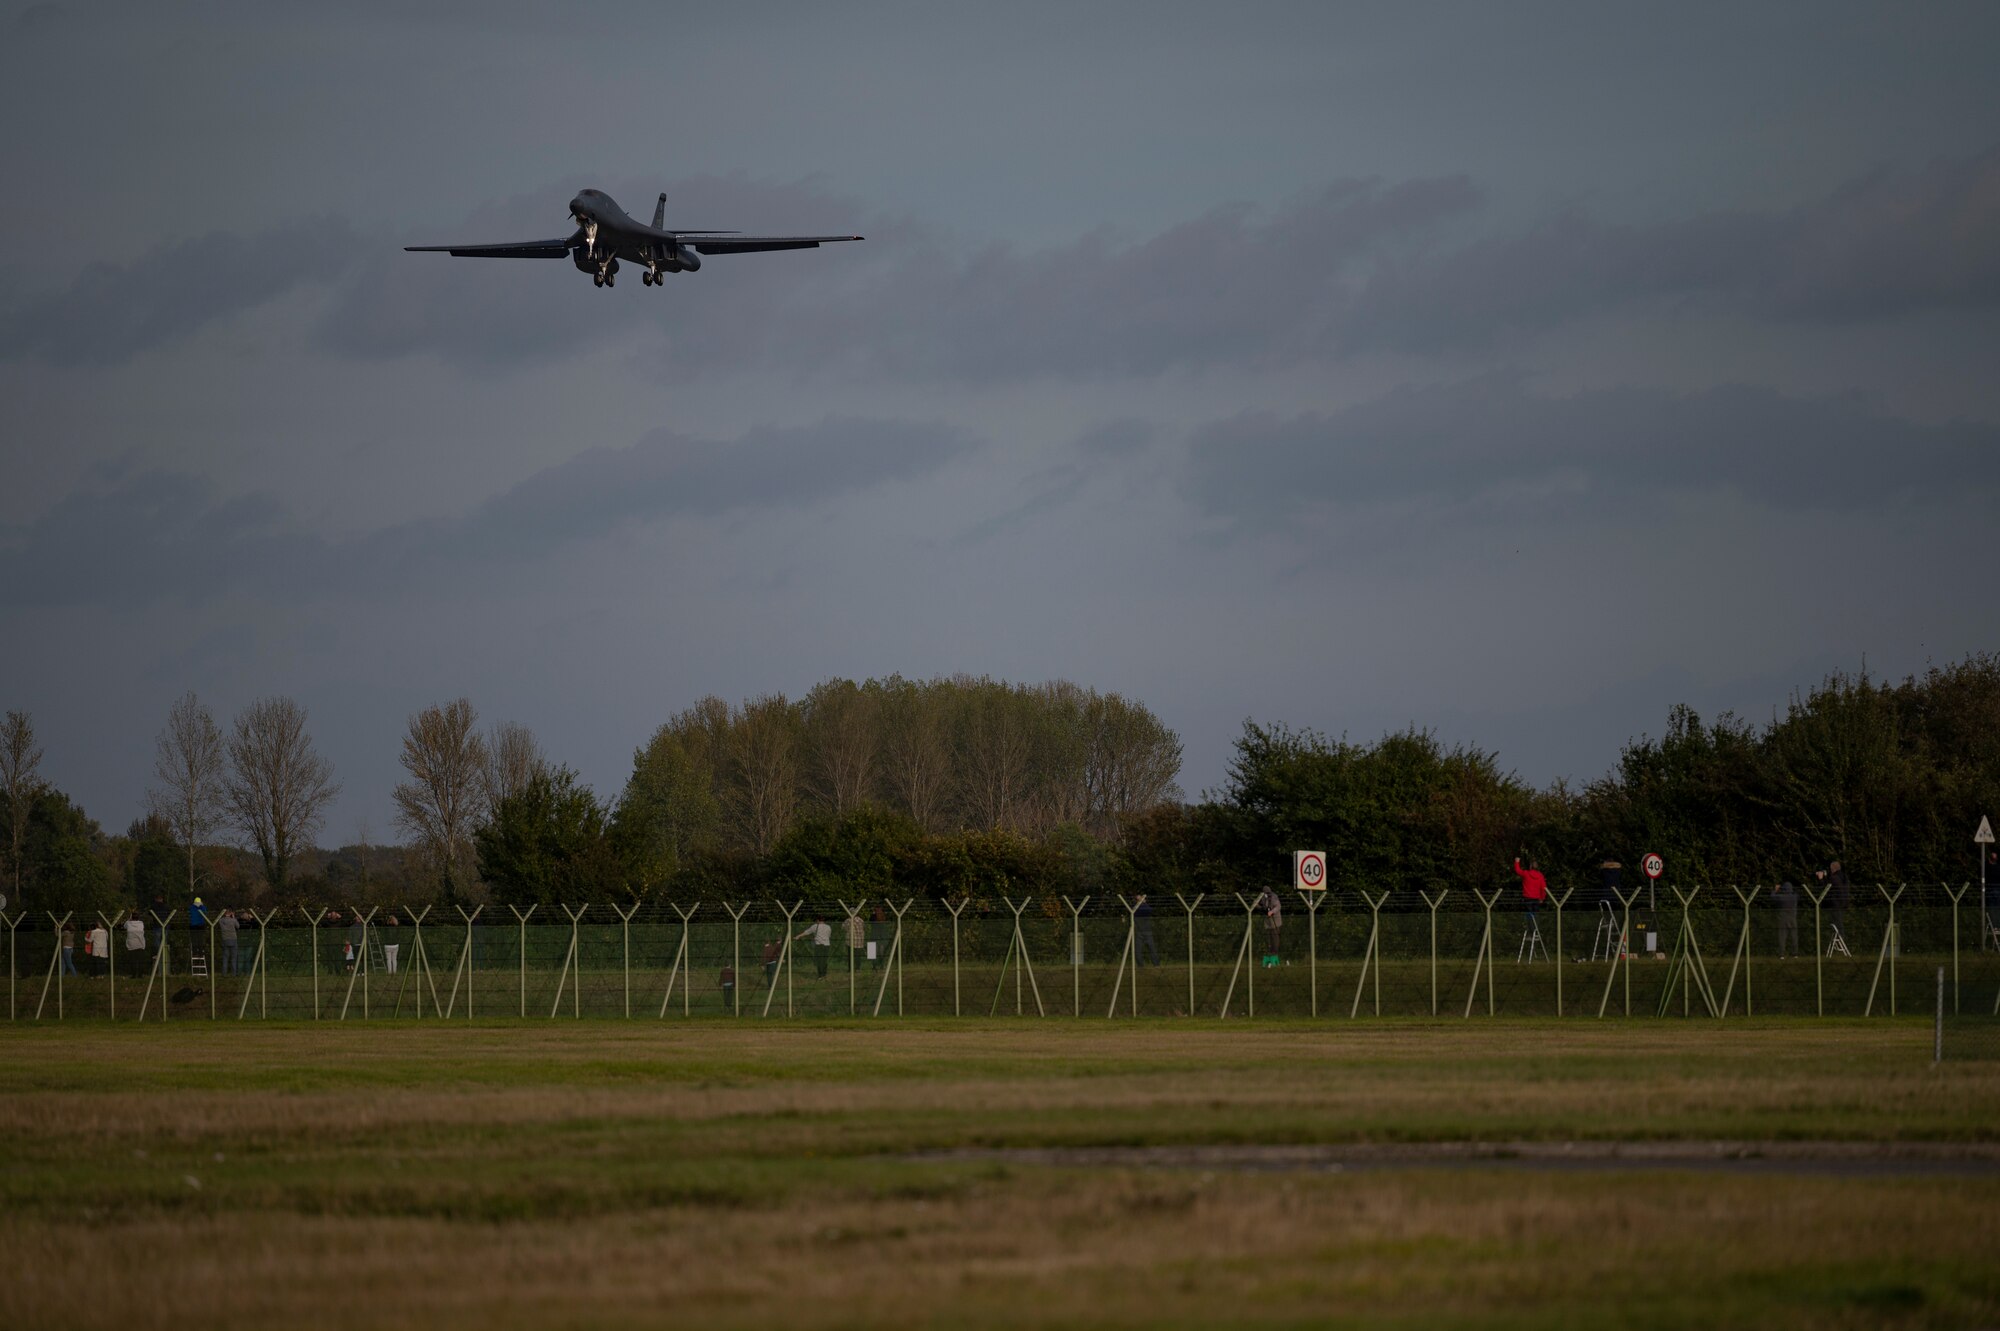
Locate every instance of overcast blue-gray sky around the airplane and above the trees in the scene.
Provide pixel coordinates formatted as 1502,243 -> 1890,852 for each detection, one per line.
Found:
0,0 -> 2000,843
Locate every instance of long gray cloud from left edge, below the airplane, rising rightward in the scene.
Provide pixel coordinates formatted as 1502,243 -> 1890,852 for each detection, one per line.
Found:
0,418 -> 974,606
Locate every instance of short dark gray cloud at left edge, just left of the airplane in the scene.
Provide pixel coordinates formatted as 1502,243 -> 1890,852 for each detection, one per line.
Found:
0,218 -> 364,366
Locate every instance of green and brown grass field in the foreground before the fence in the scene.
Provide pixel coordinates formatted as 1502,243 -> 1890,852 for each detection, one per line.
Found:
0,1019 -> 2000,1329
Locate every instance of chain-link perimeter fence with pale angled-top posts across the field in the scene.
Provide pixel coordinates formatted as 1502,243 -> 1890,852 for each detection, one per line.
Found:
0,887 -> 2000,1019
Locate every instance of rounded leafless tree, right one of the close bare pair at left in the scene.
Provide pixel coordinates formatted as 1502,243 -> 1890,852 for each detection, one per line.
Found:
228,697 -> 340,891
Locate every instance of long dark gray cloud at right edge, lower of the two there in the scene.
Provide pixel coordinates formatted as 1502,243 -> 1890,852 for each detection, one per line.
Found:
1184,376 -> 2000,522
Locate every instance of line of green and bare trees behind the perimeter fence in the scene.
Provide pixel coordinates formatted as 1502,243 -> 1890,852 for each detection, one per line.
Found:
0,654 -> 2000,911
